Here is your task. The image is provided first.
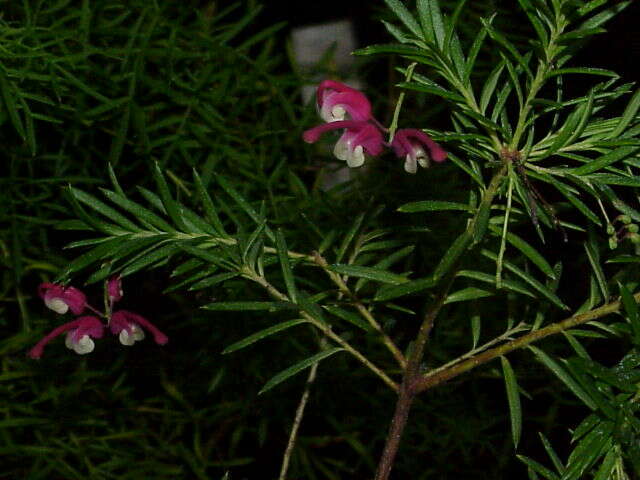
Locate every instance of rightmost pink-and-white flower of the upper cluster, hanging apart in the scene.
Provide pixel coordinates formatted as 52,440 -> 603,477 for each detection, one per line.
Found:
391,128 -> 447,173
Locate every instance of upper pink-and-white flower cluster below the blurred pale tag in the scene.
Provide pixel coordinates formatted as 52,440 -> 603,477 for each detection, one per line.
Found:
303,80 -> 447,173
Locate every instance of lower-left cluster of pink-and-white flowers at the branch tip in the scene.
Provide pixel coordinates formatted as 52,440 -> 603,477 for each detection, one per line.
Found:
29,277 -> 169,358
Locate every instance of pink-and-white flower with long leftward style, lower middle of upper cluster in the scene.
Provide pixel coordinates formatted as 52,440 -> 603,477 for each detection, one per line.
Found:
302,120 -> 383,168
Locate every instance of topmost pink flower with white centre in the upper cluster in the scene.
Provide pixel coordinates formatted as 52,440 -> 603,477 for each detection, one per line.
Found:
316,80 -> 371,122
